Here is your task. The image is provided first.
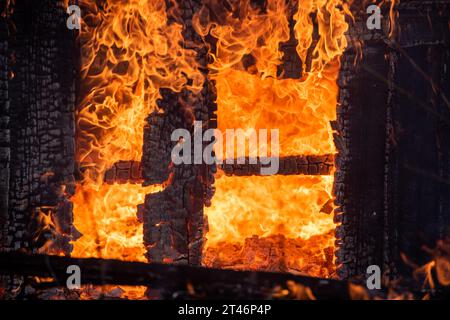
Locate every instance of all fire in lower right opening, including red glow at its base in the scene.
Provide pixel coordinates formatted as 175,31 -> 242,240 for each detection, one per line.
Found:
203,176 -> 335,277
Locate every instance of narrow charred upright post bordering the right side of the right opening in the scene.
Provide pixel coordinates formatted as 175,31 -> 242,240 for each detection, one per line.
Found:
333,48 -> 387,278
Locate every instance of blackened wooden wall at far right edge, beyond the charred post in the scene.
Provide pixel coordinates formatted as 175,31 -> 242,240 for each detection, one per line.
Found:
386,44 -> 450,273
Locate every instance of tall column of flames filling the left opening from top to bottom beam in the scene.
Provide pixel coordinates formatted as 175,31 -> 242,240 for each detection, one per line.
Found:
72,0 -> 203,261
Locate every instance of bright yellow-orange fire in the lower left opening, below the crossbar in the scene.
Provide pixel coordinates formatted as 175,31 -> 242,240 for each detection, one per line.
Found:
72,184 -> 160,262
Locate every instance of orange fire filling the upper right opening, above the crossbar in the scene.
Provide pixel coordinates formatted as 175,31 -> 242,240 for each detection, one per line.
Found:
214,70 -> 337,156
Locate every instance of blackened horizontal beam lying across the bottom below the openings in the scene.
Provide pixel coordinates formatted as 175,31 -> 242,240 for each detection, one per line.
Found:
0,252 -> 350,299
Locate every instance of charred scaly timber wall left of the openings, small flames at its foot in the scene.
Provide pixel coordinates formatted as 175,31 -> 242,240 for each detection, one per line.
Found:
2,0 -> 77,254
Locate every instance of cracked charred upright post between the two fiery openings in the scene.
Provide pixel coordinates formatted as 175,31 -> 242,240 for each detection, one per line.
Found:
142,0 -> 217,265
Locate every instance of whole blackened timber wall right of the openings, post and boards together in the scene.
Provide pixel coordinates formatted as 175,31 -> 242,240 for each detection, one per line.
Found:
334,1 -> 450,279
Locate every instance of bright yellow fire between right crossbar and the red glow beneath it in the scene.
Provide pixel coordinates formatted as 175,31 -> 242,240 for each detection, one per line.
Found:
207,176 -> 334,246
